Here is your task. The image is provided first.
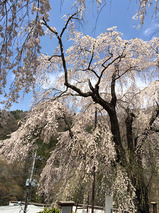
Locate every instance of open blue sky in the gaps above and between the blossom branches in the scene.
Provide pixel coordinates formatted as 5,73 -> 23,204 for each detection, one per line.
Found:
7,0 -> 159,111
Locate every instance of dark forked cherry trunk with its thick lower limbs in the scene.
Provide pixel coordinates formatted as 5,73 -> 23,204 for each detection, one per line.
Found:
69,70 -> 149,213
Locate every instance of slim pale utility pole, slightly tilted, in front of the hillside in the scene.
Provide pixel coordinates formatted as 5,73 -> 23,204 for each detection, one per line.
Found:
24,150 -> 37,213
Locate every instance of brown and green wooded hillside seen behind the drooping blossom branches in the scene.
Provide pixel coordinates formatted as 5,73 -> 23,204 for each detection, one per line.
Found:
0,105 -> 71,206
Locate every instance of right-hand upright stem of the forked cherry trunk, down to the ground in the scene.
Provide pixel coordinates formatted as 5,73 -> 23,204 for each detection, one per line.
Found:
125,109 -> 149,213
